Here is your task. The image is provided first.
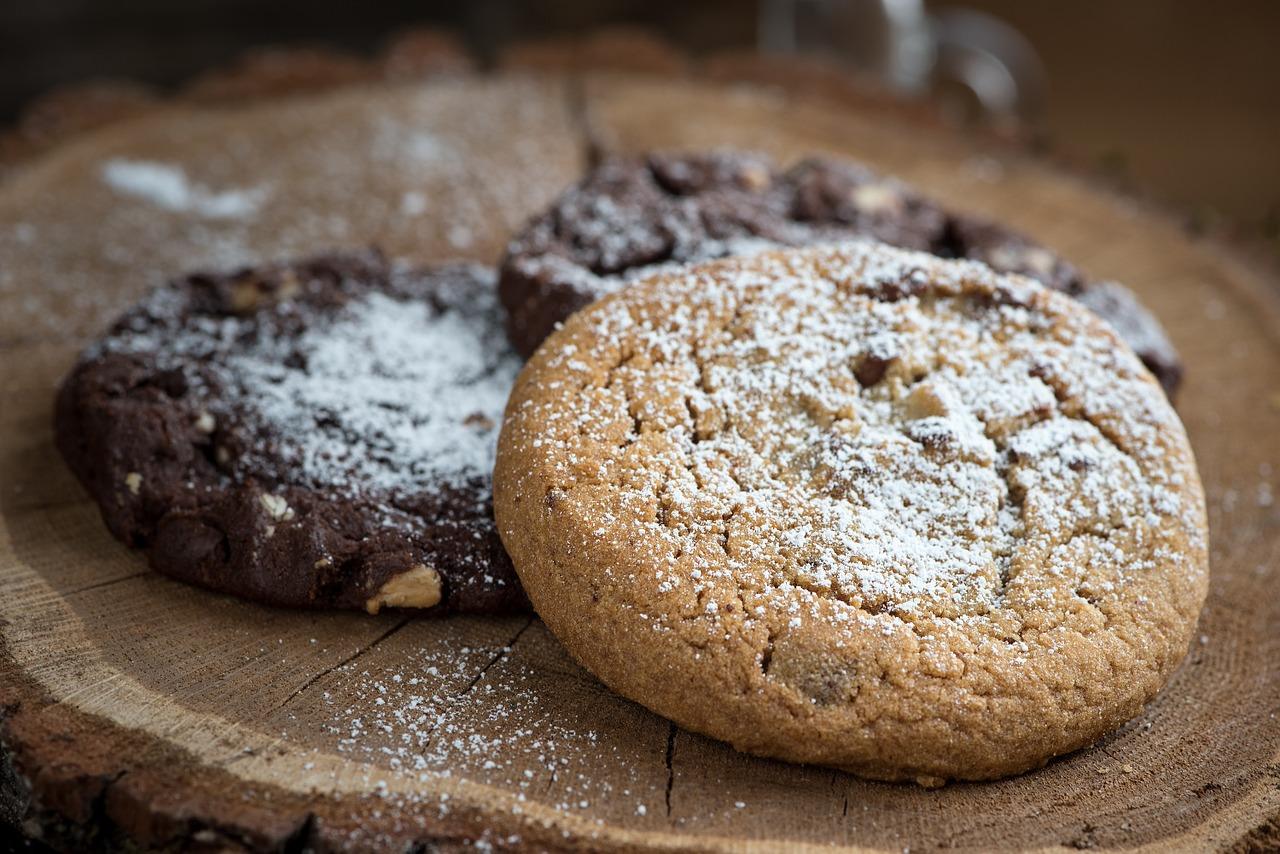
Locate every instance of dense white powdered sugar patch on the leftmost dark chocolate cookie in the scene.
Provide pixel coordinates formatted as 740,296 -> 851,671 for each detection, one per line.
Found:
235,293 -> 520,492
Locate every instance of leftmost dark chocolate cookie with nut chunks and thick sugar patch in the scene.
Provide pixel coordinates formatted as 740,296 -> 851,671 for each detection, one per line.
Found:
55,254 -> 527,612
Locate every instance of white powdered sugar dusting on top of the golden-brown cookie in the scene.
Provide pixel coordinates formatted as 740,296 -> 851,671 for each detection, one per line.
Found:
520,243 -> 1204,630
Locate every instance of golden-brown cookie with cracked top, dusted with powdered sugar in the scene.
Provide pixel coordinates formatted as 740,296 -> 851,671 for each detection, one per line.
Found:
494,241 -> 1208,785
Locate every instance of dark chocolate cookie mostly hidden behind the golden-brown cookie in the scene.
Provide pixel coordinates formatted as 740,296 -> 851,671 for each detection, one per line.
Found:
499,151 -> 1181,394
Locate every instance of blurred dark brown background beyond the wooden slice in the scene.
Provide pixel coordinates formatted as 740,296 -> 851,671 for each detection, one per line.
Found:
0,0 -> 1280,241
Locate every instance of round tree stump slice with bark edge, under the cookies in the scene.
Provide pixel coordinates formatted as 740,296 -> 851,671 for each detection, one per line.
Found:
0,58 -> 1280,850
